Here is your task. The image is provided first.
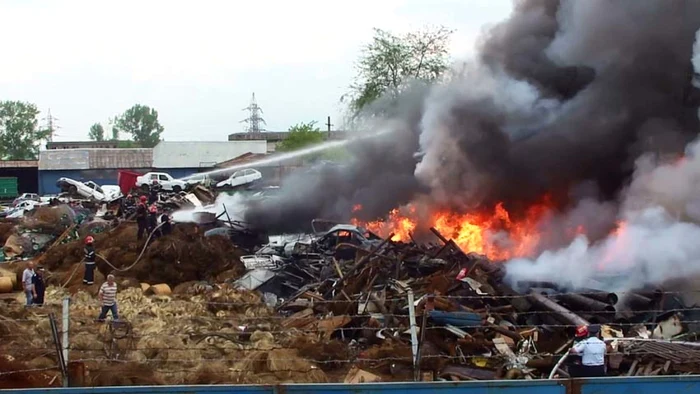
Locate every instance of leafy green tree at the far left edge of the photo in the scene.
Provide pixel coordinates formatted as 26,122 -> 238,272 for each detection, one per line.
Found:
0,101 -> 50,160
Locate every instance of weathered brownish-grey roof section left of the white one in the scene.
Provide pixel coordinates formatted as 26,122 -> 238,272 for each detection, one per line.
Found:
39,148 -> 153,170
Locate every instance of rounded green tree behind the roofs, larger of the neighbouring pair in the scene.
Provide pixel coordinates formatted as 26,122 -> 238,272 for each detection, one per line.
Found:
115,104 -> 164,148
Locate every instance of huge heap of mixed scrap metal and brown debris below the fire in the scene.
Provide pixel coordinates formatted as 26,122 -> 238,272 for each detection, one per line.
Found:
0,208 -> 700,387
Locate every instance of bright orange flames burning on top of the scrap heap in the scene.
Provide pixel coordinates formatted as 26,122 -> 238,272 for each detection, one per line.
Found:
352,197 -> 560,260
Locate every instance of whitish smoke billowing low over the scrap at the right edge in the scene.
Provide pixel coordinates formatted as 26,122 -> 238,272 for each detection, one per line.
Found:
506,142 -> 700,291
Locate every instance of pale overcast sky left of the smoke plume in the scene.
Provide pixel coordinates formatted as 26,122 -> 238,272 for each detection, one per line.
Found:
0,0 -> 512,141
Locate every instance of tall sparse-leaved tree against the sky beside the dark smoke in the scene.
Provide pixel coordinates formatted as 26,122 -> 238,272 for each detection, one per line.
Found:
341,26 -> 452,115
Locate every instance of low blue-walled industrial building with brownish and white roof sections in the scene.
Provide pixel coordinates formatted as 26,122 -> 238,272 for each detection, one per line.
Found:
38,140 -> 267,195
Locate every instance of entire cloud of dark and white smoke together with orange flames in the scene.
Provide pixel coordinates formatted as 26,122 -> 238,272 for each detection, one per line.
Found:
246,0 -> 700,288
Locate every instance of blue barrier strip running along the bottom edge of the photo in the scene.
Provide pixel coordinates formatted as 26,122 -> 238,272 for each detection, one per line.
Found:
3,375 -> 700,394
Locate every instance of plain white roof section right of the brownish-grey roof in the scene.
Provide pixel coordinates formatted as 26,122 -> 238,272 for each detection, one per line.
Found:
153,140 -> 267,168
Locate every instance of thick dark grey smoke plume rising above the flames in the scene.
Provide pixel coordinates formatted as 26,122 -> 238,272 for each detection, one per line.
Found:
246,0 -> 700,235
